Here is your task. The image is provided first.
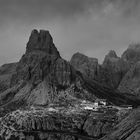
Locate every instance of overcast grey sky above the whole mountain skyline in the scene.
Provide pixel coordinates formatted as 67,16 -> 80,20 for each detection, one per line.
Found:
0,0 -> 140,64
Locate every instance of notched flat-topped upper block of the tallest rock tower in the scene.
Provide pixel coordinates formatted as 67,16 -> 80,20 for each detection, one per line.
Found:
26,29 -> 59,56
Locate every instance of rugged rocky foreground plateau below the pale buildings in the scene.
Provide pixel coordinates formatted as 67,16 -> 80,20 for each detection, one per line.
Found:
0,102 -> 128,140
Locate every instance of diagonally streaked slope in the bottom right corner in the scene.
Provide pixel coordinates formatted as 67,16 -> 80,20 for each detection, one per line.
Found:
101,108 -> 140,140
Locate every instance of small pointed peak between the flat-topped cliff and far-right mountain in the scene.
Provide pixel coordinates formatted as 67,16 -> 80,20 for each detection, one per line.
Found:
102,50 -> 129,89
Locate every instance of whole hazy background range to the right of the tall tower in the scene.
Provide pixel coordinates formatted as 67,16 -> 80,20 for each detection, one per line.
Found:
70,44 -> 140,98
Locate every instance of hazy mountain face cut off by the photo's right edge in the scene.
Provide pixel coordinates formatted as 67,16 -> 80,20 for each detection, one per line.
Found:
118,44 -> 140,96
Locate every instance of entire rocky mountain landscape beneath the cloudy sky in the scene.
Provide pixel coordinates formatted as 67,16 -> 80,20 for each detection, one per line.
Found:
0,29 -> 140,140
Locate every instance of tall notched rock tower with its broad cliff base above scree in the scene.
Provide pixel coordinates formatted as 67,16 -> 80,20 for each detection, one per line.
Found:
12,30 -> 73,86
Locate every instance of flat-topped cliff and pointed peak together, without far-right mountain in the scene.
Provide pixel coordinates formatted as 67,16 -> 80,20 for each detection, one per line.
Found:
70,51 -> 129,89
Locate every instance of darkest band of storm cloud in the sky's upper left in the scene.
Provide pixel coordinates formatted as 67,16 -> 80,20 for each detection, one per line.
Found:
0,0 -> 96,20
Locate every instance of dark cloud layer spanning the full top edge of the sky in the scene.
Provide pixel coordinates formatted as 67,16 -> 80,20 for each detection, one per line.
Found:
0,0 -> 140,23
